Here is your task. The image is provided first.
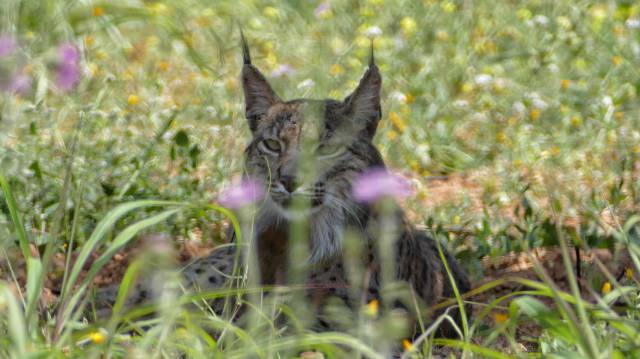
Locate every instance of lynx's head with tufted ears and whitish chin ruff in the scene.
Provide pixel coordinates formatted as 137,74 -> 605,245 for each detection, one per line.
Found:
242,37 -> 383,262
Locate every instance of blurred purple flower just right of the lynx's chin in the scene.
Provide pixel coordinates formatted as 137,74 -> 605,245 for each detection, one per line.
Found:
353,168 -> 411,203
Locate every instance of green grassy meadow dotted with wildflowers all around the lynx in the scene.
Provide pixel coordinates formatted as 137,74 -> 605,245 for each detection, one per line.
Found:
0,0 -> 640,358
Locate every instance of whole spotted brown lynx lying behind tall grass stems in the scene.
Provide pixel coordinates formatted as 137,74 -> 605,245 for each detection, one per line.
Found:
92,36 -> 470,342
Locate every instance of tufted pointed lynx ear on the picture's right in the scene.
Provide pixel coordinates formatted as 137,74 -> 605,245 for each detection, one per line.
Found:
344,43 -> 382,138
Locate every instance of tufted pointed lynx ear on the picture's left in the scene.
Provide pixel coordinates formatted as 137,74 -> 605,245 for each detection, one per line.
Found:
240,31 -> 281,132
